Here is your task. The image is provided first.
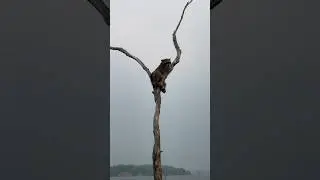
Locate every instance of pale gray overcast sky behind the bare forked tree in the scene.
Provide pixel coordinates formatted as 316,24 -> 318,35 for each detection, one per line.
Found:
110,0 -> 210,170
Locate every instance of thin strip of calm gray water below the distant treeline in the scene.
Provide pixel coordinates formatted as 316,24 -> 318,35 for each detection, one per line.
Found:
110,176 -> 210,180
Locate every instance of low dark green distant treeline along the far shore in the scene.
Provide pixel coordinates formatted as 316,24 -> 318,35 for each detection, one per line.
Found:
110,164 -> 191,177
